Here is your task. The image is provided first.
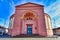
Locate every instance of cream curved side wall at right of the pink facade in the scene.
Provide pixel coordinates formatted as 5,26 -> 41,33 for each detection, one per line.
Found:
45,14 -> 53,36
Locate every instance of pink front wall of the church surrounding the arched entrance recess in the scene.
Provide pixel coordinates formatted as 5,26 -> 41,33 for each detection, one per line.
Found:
9,4 -> 47,36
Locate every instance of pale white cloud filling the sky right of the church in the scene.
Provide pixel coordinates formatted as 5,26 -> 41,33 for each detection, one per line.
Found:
44,0 -> 60,27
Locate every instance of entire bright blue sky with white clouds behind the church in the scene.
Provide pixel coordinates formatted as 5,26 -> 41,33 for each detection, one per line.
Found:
0,0 -> 60,28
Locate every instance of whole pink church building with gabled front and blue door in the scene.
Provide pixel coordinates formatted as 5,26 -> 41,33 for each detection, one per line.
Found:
8,2 -> 53,37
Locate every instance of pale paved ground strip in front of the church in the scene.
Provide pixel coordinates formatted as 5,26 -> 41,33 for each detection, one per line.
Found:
0,38 -> 60,40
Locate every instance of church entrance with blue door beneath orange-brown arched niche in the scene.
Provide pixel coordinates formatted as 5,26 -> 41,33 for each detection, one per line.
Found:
24,12 -> 36,35
